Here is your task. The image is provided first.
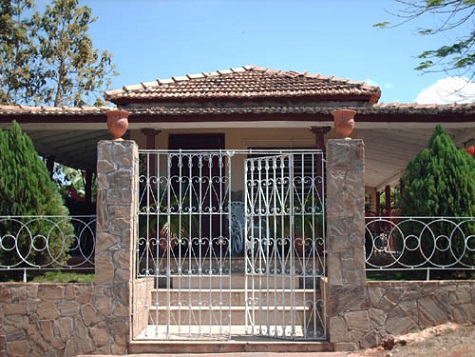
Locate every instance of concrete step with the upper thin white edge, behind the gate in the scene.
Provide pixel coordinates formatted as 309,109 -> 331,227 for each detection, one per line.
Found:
150,289 -> 320,306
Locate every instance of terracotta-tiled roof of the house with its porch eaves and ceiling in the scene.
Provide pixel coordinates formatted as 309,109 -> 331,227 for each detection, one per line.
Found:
0,66 -> 475,208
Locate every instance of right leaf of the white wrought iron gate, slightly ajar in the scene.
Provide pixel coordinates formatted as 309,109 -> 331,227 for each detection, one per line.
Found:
245,152 -> 326,339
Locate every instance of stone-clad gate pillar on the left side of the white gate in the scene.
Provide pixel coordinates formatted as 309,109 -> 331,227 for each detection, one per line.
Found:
94,140 -> 138,354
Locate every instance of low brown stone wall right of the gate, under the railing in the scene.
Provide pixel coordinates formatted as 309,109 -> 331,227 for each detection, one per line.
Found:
330,281 -> 475,350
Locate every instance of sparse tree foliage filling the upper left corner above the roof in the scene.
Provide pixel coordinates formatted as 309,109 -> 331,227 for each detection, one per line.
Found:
0,0 -> 117,106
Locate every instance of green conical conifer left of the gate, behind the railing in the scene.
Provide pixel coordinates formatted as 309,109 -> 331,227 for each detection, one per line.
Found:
0,122 -> 73,266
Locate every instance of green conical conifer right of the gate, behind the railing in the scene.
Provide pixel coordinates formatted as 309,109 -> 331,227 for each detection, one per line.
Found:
393,125 -> 475,266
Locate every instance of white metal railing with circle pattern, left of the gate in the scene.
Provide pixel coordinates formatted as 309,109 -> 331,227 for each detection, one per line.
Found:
0,216 -> 96,281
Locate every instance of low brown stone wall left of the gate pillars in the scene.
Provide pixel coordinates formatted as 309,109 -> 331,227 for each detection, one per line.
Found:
0,283 -> 96,356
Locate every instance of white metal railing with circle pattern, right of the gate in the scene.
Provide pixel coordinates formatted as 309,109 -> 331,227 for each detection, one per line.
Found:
366,217 -> 475,279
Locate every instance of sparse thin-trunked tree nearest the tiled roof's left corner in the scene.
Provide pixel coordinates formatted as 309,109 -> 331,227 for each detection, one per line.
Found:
36,0 -> 113,106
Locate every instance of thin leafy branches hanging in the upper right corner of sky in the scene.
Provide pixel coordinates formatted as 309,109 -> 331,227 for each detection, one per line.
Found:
374,0 -> 475,79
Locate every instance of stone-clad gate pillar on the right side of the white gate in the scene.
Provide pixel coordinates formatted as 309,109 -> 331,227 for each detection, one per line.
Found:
326,139 -> 370,350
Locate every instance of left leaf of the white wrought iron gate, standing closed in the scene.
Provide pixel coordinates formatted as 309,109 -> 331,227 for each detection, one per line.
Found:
137,151 -> 232,339
